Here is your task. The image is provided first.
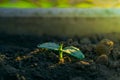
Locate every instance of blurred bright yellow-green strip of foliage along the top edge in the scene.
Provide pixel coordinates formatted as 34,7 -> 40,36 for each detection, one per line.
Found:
0,0 -> 120,8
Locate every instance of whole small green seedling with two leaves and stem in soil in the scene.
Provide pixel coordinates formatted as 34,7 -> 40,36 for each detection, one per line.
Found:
37,42 -> 85,63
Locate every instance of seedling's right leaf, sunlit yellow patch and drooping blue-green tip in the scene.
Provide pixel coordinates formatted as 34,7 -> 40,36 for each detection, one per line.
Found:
63,46 -> 85,59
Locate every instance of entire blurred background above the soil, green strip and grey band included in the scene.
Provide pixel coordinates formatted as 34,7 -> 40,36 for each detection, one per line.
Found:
0,0 -> 120,36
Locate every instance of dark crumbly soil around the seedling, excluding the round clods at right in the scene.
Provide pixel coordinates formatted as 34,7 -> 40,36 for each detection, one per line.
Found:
0,33 -> 120,80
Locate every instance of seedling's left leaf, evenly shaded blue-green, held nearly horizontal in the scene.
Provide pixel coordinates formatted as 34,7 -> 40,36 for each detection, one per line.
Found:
37,42 -> 60,50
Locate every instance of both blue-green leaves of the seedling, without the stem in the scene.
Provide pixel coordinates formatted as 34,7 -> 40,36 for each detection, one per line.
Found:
37,42 -> 85,59
